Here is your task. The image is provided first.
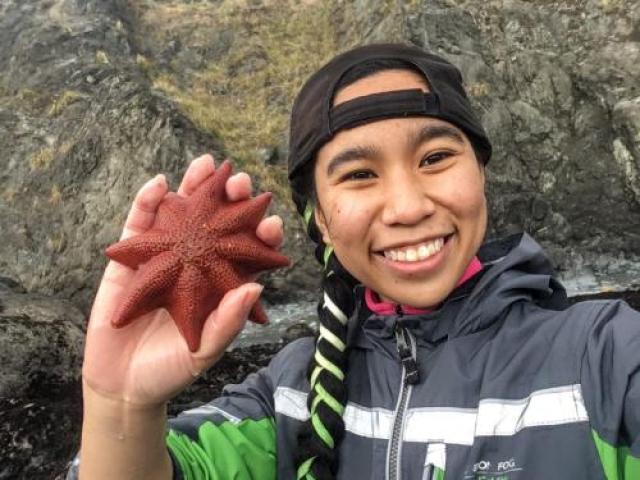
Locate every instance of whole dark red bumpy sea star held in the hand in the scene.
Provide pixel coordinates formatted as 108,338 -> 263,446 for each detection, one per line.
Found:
106,162 -> 289,352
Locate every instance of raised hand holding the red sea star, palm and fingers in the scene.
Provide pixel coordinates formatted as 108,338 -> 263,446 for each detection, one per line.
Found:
82,155 -> 283,407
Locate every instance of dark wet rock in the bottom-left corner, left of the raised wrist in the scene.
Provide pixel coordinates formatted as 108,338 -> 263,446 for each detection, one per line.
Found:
0,277 -> 85,480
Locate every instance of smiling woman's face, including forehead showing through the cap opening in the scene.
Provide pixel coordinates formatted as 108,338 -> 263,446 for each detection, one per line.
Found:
314,70 -> 487,307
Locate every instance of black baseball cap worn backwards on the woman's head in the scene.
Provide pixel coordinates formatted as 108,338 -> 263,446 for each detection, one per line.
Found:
288,44 -> 491,218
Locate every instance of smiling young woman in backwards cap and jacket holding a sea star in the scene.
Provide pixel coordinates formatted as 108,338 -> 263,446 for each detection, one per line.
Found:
68,44 -> 640,480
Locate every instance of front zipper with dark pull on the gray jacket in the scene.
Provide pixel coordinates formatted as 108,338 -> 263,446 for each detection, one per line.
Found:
387,305 -> 420,480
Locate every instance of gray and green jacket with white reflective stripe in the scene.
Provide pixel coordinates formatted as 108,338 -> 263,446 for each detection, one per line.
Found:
68,234 -> 640,480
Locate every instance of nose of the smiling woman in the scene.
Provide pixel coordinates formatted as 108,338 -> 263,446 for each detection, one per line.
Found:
382,174 -> 435,225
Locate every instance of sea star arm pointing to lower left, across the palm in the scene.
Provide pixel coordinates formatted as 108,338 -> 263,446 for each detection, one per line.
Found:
111,252 -> 182,327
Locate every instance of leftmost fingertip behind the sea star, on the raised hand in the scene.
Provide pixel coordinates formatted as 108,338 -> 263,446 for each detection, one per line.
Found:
120,174 -> 168,240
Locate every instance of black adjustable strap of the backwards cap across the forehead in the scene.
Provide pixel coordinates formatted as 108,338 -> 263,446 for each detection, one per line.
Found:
329,88 -> 440,135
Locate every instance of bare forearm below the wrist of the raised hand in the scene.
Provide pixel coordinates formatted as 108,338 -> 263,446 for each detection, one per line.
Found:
80,385 -> 172,480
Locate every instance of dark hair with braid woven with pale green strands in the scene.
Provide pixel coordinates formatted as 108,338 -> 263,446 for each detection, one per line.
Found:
291,60 -> 417,480
